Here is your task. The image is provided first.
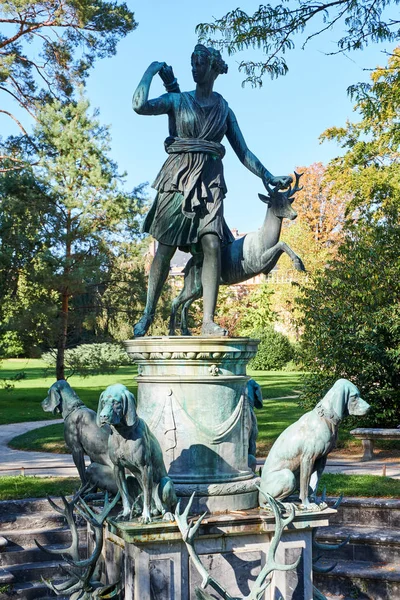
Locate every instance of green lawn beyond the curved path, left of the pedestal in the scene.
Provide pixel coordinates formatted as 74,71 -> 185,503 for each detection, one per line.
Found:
0,358 -> 137,425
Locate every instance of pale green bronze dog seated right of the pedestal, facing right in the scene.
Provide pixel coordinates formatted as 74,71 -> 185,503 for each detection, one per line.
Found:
260,379 -> 370,509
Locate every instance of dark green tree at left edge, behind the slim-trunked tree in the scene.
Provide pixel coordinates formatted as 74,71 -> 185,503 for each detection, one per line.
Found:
0,170 -> 56,356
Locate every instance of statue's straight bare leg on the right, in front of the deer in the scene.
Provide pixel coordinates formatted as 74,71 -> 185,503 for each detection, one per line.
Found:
201,233 -> 228,336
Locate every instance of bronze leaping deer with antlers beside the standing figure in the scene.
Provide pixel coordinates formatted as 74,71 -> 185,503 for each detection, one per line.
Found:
169,173 -> 305,335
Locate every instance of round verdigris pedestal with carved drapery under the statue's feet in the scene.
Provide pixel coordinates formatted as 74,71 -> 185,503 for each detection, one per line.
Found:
125,337 -> 258,512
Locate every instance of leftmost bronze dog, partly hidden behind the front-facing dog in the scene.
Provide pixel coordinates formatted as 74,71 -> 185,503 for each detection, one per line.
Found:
42,379 -> 118,494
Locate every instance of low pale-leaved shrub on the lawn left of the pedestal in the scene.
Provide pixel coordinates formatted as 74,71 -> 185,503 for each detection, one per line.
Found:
42,343 -> 130,377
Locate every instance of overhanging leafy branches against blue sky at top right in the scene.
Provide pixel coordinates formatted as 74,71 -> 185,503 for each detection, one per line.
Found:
197,0 -> 400,85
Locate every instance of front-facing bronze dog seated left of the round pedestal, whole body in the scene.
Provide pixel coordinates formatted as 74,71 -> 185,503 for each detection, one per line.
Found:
97,383 -> 177,523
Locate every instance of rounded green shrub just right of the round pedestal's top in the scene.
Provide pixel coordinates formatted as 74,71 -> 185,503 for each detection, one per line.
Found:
249,327 -> 294,371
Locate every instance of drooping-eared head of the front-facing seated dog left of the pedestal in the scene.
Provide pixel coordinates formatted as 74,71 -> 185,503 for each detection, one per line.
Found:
97,383 -> 137,427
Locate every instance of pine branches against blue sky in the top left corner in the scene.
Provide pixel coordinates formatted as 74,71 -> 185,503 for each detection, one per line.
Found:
0,0 -> 137,170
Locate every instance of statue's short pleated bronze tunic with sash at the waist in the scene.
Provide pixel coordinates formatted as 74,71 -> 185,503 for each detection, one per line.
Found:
143,92 -> 234,251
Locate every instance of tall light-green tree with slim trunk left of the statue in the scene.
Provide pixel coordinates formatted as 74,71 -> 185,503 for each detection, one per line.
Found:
30,97 -> 142,379
